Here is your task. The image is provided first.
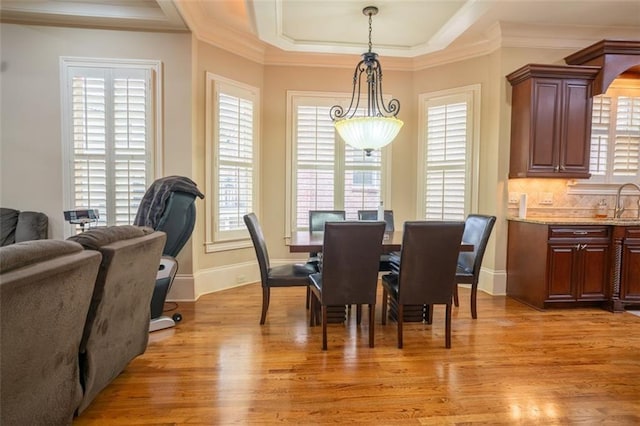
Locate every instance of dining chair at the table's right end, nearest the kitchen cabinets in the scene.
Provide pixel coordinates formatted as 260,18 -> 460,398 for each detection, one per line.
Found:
453,214 -> 496,319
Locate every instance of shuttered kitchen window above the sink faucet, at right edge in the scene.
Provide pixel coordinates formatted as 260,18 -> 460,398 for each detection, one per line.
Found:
589,79 -> 640,185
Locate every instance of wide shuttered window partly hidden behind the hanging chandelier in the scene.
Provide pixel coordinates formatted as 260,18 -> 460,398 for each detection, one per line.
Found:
287,92 -> 391,235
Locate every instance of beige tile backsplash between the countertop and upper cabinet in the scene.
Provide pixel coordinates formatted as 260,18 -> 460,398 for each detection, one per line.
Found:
508,179 -> 638,218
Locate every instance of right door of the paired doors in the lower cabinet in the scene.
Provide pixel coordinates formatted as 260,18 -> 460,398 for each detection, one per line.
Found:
577,243 -> 609,300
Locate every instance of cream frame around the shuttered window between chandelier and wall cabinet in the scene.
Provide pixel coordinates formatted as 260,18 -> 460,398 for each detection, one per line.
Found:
416,84 -> 481,220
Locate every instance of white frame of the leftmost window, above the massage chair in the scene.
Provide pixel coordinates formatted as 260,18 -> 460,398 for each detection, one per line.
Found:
59,56 -> 164,238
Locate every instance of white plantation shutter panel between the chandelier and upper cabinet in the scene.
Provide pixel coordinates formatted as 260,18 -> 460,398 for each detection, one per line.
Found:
423,101 -> 469,220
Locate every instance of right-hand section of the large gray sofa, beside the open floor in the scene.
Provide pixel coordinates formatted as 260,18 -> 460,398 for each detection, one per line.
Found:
69,225 -> 166,414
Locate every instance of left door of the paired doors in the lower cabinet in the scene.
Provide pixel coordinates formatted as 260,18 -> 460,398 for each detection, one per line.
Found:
547,244 -> 576,301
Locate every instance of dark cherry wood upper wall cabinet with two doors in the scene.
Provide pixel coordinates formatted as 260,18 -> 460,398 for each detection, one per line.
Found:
507,64 -> 600,178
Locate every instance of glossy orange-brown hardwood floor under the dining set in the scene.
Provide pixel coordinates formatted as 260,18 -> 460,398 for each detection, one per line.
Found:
74,284 -> 640,425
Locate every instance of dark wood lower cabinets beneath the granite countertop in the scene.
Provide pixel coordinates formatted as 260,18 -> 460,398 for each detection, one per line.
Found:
507,220 -> 640,312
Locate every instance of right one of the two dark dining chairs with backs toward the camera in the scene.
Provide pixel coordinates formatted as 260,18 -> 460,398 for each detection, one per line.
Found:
382,221 -> 464,348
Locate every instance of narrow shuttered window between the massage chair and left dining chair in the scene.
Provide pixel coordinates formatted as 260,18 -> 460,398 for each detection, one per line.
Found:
206,73 -> 260,251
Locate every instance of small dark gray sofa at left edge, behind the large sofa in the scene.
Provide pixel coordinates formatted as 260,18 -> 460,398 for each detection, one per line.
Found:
0,207 -> 49,247
